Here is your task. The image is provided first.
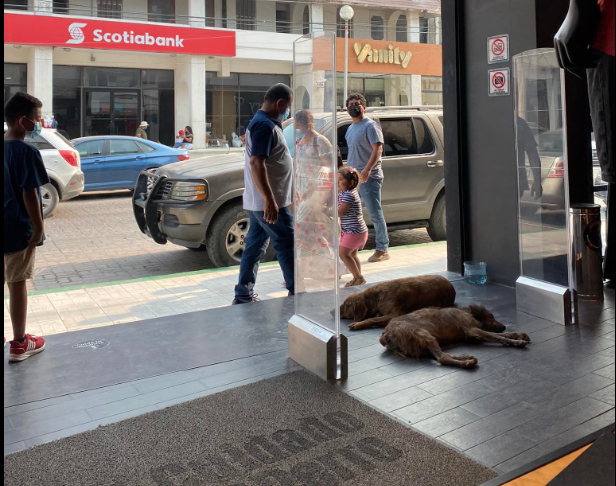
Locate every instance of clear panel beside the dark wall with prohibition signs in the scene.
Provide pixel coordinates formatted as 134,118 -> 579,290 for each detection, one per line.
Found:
513,49 -> 570,287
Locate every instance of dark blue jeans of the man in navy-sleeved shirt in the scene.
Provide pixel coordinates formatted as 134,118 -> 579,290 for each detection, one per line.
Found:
235,208 -> 295,302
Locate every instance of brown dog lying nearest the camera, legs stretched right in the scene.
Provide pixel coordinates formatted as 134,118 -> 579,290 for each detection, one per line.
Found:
381,305 -> 530,368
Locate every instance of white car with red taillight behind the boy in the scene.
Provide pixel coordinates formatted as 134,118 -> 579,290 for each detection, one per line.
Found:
4,123 -> 84,218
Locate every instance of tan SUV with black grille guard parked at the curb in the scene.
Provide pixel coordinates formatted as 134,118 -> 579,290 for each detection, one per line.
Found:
133,107 -> 446,267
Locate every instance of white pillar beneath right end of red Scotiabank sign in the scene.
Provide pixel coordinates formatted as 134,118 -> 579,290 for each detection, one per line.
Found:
175,56 -> 206,150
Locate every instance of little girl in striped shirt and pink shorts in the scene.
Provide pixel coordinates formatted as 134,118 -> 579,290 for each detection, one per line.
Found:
338,167 -> 368,287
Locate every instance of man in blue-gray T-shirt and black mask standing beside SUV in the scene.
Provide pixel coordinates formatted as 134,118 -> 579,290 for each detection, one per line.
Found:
346,93 -> 389,263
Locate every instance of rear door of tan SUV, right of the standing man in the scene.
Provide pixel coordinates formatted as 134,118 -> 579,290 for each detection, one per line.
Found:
379,114 -> 444,223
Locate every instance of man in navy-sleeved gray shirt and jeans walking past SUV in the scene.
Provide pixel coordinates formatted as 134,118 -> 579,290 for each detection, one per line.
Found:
233,84 -> 295,305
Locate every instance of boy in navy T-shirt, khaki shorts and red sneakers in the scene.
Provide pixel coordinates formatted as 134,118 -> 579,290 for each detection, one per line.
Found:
4,92 -> 49,362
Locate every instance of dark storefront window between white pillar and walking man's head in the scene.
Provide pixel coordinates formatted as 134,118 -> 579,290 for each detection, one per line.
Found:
206,72 -> 291,146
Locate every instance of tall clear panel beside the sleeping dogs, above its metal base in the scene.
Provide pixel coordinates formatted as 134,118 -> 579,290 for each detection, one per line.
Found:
292,33 -> 345,337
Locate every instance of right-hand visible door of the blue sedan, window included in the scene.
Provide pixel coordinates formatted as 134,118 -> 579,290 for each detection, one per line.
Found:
104,138 -> 146,189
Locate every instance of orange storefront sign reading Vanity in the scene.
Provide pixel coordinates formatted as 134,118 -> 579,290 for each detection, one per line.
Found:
314,39 -> 443,76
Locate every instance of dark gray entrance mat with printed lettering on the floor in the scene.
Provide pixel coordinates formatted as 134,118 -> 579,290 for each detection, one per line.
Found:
4,372 -> 496,486
